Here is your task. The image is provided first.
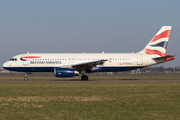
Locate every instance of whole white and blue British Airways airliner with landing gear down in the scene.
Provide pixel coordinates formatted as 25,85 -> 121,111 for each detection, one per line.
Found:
3,26 -> 175,81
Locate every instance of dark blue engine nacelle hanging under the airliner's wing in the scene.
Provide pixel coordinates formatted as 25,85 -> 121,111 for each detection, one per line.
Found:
54,68 -> 79,77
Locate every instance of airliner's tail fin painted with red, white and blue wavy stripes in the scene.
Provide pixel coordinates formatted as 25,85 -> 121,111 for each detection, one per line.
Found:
140,26 -> 172,57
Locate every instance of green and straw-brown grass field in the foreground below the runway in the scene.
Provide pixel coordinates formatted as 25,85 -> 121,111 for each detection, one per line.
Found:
0,75 -> 180,120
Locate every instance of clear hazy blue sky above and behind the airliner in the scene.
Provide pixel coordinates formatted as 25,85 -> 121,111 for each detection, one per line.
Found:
0,0 -> 180,68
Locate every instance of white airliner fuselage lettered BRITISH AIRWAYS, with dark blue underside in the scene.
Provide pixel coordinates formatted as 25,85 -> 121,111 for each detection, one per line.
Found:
3,53 -> 156,72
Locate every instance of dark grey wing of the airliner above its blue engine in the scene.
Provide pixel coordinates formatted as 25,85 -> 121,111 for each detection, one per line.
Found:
72,60 -> 108,70
